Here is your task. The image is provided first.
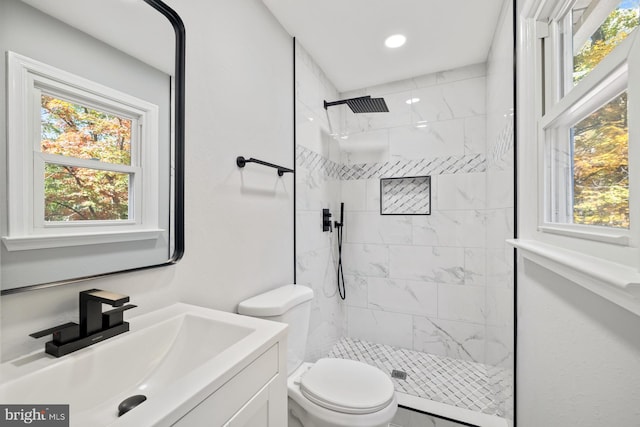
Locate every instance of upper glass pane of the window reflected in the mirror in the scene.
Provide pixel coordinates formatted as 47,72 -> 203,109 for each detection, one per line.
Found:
40,95 -> 131,165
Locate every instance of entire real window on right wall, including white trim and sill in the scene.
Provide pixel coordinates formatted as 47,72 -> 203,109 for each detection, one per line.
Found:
510,0 -> 640,314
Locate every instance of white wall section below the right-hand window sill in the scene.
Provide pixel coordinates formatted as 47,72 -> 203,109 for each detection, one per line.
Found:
517,261 -> 640,427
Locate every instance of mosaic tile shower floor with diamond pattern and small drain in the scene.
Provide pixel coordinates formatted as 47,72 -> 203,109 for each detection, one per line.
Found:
328,337 -> 513,417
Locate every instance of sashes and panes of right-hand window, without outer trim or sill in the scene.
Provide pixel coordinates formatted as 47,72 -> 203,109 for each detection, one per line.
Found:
539,0 -> 640,245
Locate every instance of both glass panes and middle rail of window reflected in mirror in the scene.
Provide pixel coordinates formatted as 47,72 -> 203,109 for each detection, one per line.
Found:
40,93 -> 138,224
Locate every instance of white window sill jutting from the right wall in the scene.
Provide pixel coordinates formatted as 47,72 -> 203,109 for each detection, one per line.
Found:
507,239 -> 640,315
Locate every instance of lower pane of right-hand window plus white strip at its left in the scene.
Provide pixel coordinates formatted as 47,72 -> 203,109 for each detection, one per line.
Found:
547,91 -> 629,229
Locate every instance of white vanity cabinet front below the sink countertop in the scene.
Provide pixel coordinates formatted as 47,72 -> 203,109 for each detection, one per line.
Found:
173,344 -> 287,427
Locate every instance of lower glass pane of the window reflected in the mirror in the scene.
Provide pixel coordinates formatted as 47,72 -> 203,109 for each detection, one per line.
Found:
44,163 -> 130,222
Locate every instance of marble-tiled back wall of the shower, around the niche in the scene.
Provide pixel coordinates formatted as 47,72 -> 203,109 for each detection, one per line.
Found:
324,64 -> 498,362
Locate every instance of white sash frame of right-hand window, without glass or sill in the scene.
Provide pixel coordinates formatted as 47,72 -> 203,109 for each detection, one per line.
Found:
537,1 -> 640,247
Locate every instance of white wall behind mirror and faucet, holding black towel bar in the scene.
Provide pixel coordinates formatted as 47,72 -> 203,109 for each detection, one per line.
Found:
0,0 -> 293,360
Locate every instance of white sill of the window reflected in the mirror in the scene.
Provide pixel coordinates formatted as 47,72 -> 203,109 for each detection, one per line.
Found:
2,229 -> 164,251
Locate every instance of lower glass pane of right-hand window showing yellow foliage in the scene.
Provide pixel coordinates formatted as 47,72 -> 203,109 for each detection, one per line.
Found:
571,92 -> 629,228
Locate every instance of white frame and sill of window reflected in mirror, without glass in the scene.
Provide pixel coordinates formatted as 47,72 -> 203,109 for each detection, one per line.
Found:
2,51 -> 164,251
